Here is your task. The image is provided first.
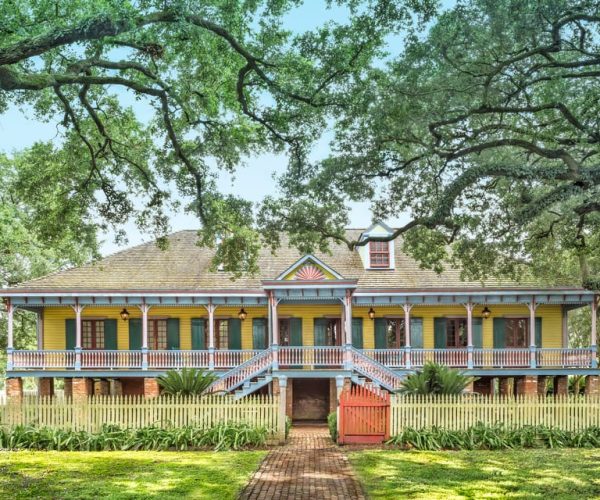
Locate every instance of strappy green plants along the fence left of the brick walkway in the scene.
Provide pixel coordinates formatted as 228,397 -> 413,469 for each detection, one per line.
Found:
0,423 -> 271,451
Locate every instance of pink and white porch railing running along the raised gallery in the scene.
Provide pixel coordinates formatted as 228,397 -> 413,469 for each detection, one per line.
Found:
9,346 -> 595,370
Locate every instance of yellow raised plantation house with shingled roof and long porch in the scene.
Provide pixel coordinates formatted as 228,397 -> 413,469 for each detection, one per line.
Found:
3,223 -> 600,419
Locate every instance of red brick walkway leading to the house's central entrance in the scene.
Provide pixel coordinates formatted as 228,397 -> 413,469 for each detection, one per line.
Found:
240,425 -> 365,500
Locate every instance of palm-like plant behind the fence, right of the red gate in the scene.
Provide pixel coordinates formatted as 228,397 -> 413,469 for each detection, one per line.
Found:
399,363 -> 475,394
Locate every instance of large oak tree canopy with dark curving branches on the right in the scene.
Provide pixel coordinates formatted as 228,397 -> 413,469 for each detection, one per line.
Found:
269,0 -> 600,289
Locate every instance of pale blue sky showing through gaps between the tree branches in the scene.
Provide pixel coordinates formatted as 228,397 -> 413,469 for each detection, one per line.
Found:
0,0 -> 447,255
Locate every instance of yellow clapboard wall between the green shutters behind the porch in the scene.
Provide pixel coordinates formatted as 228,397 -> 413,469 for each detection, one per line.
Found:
43,303 -> 562,350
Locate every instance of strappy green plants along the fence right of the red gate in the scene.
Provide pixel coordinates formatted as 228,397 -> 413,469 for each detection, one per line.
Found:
388,424 -> 600,450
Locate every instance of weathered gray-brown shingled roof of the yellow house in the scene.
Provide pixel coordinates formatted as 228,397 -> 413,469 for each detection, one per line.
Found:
8,229 -> 564,291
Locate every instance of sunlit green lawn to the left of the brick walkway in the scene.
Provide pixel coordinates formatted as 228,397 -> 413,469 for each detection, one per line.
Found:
0,451 -> 266,500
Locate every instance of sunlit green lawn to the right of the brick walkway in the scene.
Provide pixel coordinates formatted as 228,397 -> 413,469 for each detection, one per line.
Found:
350,449 -> 600,500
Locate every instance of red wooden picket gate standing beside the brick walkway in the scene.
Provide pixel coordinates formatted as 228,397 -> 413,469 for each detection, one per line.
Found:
338,386 -> 390,444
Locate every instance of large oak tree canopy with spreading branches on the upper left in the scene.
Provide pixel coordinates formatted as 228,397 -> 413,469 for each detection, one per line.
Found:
0,0 -> 436,276
